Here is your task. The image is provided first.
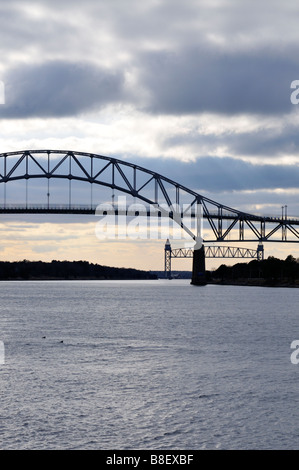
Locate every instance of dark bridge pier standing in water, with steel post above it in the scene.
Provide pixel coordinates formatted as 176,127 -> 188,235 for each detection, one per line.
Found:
191,200 -> 207,286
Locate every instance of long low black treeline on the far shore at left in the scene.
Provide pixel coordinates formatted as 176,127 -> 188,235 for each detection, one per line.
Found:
0,260 -> 157,280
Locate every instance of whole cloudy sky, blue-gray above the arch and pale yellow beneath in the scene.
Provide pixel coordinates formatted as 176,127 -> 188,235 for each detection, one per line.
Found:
0,0 -> 299,269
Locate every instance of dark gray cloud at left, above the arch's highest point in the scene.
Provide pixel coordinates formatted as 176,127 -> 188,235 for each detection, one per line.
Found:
0,61 -> 126,118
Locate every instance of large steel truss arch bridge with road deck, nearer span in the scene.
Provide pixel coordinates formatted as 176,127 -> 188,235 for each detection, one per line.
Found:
0,150 -> 299,243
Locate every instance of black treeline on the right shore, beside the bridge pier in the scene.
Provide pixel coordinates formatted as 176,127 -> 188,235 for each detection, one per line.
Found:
209,255 -> 299,286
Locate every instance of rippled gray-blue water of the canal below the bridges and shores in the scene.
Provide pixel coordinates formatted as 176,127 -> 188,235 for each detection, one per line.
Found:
0,280 -> 299,450
